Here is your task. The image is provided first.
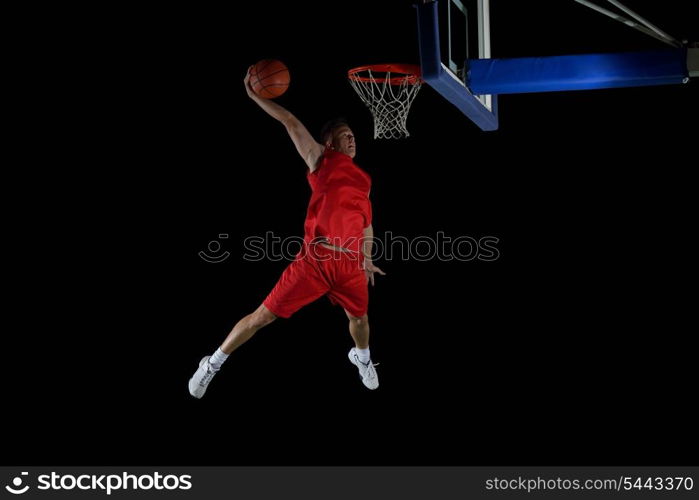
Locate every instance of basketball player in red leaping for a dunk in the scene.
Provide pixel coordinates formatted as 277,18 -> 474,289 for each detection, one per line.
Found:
189,69 -> 385,398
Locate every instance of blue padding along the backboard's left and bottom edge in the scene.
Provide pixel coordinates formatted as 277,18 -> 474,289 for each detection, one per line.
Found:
416,2 -> 498,130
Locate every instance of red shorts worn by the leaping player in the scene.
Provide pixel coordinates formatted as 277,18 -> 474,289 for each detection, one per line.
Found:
263,244 -> 369,318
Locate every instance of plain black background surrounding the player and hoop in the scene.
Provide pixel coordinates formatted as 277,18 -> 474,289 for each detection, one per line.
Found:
2,0 -> 699,465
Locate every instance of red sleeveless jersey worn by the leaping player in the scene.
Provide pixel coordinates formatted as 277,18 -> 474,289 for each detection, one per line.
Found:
304,150 -> 371,252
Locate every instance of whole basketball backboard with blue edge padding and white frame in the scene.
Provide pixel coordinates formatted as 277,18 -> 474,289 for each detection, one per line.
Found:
416,0 -> 498,130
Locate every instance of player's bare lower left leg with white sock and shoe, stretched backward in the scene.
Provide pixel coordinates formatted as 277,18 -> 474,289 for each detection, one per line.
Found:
189,304 -> 277,398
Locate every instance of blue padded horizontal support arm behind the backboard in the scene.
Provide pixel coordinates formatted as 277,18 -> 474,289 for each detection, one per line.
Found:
467,49 -> 688,94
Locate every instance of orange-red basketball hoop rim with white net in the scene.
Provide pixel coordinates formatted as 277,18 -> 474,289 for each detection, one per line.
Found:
347,64 -> 422,139
